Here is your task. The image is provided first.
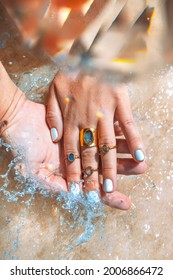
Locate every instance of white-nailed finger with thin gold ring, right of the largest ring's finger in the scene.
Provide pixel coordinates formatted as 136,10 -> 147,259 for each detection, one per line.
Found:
99,114 -> 117,192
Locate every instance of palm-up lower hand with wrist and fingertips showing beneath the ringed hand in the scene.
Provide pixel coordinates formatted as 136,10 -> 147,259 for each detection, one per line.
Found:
0,64 -> 146,210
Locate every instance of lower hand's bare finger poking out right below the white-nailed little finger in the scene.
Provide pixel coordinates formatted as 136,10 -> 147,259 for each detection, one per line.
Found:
117,158 -> 147,175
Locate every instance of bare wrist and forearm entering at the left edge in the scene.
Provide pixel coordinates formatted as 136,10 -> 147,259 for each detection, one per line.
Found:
0,62 -> 23,121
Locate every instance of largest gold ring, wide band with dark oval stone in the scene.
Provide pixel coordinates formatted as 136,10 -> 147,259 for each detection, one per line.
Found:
80,128 -> 97,148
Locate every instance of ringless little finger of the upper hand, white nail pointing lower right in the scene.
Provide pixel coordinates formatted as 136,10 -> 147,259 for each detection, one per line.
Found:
116,86 -> 145,162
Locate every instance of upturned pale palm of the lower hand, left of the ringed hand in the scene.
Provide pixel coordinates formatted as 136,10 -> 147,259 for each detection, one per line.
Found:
0,93 -> 67,192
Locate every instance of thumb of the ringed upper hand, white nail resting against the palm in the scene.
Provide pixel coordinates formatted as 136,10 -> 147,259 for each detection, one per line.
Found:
46,89 -> 63,143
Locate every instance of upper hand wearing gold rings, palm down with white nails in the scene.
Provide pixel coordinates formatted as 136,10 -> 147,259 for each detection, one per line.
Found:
47,74 -> 146,205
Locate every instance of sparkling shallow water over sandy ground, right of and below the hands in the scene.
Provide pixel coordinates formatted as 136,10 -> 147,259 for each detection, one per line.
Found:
0,62 -> 173,259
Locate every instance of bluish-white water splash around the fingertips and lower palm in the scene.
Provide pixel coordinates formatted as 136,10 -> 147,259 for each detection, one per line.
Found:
0,135 -> 104,250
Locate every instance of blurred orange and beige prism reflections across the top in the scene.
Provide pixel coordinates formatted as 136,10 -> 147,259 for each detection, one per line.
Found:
0,0 -> 173,75
